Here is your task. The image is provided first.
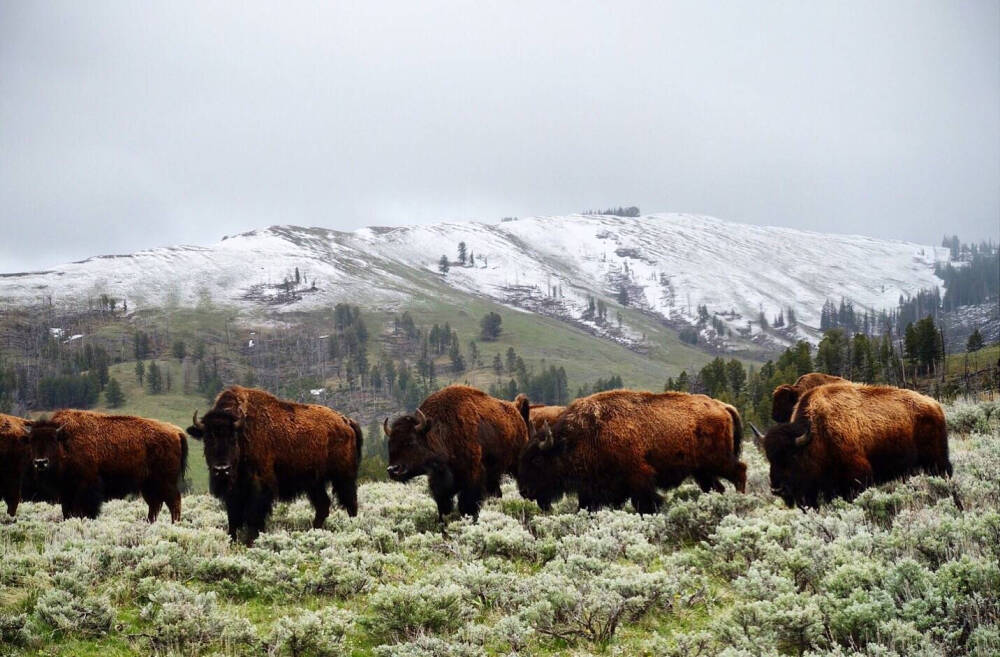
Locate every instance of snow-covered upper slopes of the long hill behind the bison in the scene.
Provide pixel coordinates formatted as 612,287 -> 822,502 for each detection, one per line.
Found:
0,214 -> 948,344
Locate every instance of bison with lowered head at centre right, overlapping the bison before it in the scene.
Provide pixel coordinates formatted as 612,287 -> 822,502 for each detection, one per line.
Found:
518,390 -> 746,513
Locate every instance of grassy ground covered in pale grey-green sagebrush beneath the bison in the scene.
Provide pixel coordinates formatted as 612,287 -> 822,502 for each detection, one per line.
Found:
0,402 -> 1000,657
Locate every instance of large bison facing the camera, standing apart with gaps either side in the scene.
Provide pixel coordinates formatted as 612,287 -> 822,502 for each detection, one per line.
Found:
187,386 -> 362,543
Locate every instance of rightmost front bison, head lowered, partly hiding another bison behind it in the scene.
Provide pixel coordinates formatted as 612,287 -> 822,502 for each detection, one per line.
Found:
752,383 -> 951,507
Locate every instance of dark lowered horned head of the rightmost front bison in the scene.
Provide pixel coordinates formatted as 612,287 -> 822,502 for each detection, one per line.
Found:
750,417 -> 821,507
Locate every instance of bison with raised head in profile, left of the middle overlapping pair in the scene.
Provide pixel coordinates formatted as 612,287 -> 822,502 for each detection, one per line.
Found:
383,385 -> 529,519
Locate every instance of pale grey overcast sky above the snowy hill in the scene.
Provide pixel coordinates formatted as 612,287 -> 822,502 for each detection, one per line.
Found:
0,0 -> 1000,271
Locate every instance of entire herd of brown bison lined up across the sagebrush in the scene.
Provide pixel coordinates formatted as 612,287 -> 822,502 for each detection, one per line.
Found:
0,374 -> 952,542
